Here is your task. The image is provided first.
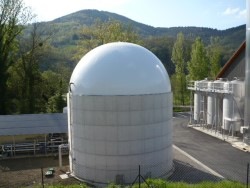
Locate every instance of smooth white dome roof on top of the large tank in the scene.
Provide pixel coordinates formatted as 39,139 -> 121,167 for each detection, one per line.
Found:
70,42 -> 171,95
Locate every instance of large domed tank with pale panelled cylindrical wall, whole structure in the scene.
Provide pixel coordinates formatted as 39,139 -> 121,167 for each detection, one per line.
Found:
68,42 -> 173,184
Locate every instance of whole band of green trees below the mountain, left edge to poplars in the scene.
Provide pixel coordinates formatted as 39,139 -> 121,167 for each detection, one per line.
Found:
0,0 -> 223,114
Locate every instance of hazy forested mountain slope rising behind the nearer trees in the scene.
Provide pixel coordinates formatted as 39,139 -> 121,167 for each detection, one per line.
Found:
30,10 -> 246,73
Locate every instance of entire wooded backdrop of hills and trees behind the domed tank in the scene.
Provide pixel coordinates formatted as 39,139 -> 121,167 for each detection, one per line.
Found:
0,8 -> 246,114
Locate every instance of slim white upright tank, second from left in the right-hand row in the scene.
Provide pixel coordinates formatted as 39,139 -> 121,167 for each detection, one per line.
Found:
207,81 -> 215,125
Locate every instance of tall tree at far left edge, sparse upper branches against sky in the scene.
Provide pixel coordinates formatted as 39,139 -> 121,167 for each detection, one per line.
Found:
0,0 -> 32,114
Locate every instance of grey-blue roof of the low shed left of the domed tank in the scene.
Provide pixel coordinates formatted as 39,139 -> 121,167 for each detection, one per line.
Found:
0,113 -> 68,136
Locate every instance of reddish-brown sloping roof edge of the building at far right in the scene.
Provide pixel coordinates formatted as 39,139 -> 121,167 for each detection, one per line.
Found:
216,41 -> 246,79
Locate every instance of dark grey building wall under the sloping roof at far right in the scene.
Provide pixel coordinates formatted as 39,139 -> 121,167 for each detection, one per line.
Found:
220,50 -> 246,80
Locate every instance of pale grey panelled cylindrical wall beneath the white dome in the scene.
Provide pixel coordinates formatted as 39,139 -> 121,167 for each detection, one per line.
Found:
71,93 -> 173,183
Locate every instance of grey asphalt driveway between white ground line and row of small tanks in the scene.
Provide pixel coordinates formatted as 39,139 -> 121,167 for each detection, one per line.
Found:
173,113 -> 250,183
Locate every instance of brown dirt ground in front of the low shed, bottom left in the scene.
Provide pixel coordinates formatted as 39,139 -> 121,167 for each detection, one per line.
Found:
0,156 -> 81,188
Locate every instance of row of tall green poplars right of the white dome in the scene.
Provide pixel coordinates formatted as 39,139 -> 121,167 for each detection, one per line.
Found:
171,33 -> 222,105
